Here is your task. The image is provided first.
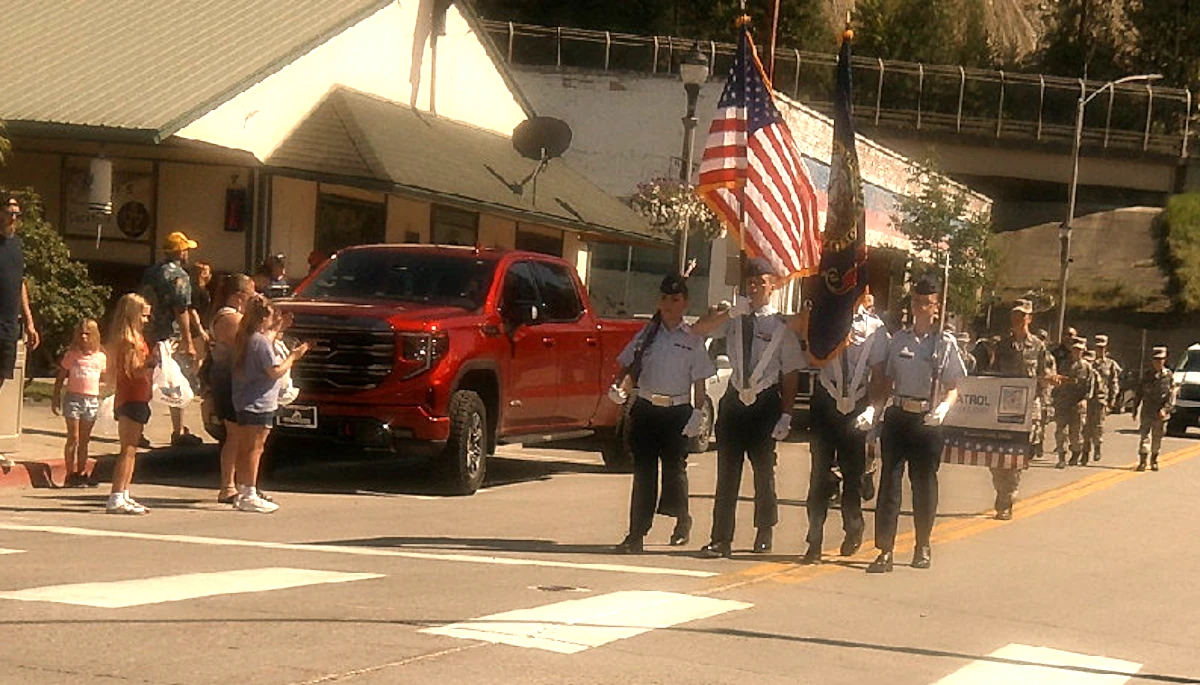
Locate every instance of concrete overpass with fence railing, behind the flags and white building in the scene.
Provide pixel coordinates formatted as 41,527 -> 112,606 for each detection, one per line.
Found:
486,22 -> 1200,230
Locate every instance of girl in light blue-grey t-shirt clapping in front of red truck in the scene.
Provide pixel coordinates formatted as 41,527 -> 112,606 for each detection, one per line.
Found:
226,295 -> 308,513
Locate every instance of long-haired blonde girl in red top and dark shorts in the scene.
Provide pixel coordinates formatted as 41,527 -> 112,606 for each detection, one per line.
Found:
106,293 -> 158,515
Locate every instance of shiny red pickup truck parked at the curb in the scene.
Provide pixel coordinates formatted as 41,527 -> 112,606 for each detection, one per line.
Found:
276,245 -> 642,494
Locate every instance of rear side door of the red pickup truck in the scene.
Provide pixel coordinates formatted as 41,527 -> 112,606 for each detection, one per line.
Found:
533,262 -> 604,427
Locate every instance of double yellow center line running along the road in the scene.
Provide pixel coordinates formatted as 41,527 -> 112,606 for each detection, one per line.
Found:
700,445 -> 1200,594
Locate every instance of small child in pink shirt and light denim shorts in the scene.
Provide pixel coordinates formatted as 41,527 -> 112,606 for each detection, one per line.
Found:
52,319 -> 108,487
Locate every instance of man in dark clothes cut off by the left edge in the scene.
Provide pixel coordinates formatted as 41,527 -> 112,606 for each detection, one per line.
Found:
0,196 -> 41,473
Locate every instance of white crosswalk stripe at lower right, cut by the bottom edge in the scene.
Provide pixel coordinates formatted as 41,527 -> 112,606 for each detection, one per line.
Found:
935,644 -> 1141,685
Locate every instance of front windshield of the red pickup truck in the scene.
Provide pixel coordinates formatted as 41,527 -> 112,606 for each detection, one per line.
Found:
298,250 -> 496,310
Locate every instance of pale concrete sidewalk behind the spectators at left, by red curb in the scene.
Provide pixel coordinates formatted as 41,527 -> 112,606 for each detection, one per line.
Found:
0,397 -> 215,488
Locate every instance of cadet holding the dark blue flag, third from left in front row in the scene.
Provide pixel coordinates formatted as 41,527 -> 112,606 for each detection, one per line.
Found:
793,297 -> 889,564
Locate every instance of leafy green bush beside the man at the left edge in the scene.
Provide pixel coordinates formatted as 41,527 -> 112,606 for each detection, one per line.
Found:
0,188 -> 110,368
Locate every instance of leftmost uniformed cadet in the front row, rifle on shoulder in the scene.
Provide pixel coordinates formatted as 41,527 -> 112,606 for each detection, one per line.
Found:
608,275 -> 716,554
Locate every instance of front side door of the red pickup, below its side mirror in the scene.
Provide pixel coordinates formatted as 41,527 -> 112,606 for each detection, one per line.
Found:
500,262 -> 559,434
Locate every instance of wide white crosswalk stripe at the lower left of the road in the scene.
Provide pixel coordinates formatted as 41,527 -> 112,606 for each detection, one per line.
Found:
0,567 -> 383,608
